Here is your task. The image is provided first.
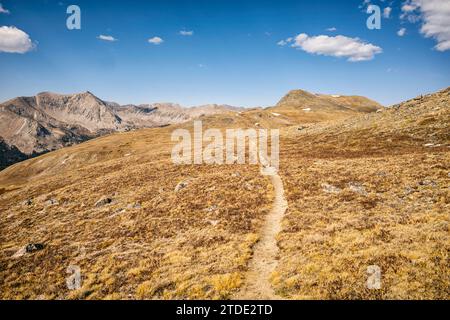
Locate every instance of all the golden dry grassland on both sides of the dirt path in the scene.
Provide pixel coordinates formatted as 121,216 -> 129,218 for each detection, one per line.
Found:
0,89 -> 450,299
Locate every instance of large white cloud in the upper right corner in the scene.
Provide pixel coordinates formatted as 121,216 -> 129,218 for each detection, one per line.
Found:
401,0 -> 450,51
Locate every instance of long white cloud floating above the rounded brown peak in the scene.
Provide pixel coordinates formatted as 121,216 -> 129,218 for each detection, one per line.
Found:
292,33 -> 383,62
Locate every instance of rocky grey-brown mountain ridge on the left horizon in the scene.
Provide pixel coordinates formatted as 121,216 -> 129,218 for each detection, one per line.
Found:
0,91 -> 243,169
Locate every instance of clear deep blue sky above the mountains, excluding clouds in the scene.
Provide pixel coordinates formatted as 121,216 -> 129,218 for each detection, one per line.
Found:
0,0 -> 450,106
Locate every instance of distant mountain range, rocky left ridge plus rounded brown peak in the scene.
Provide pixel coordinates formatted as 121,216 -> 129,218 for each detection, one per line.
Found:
0,90 -> 381,169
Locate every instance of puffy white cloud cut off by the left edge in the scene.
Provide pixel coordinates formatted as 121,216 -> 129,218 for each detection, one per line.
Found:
0,26 -> 34,53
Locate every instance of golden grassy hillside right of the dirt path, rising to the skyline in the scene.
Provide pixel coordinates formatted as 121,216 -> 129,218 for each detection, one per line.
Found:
273,89 -> 450,299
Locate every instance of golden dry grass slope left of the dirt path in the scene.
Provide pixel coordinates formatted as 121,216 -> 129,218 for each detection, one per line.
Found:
0,120 -> 272,299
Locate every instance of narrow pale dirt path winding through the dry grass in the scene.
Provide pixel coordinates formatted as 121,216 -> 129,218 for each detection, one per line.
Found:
234,167 -> 288,300
